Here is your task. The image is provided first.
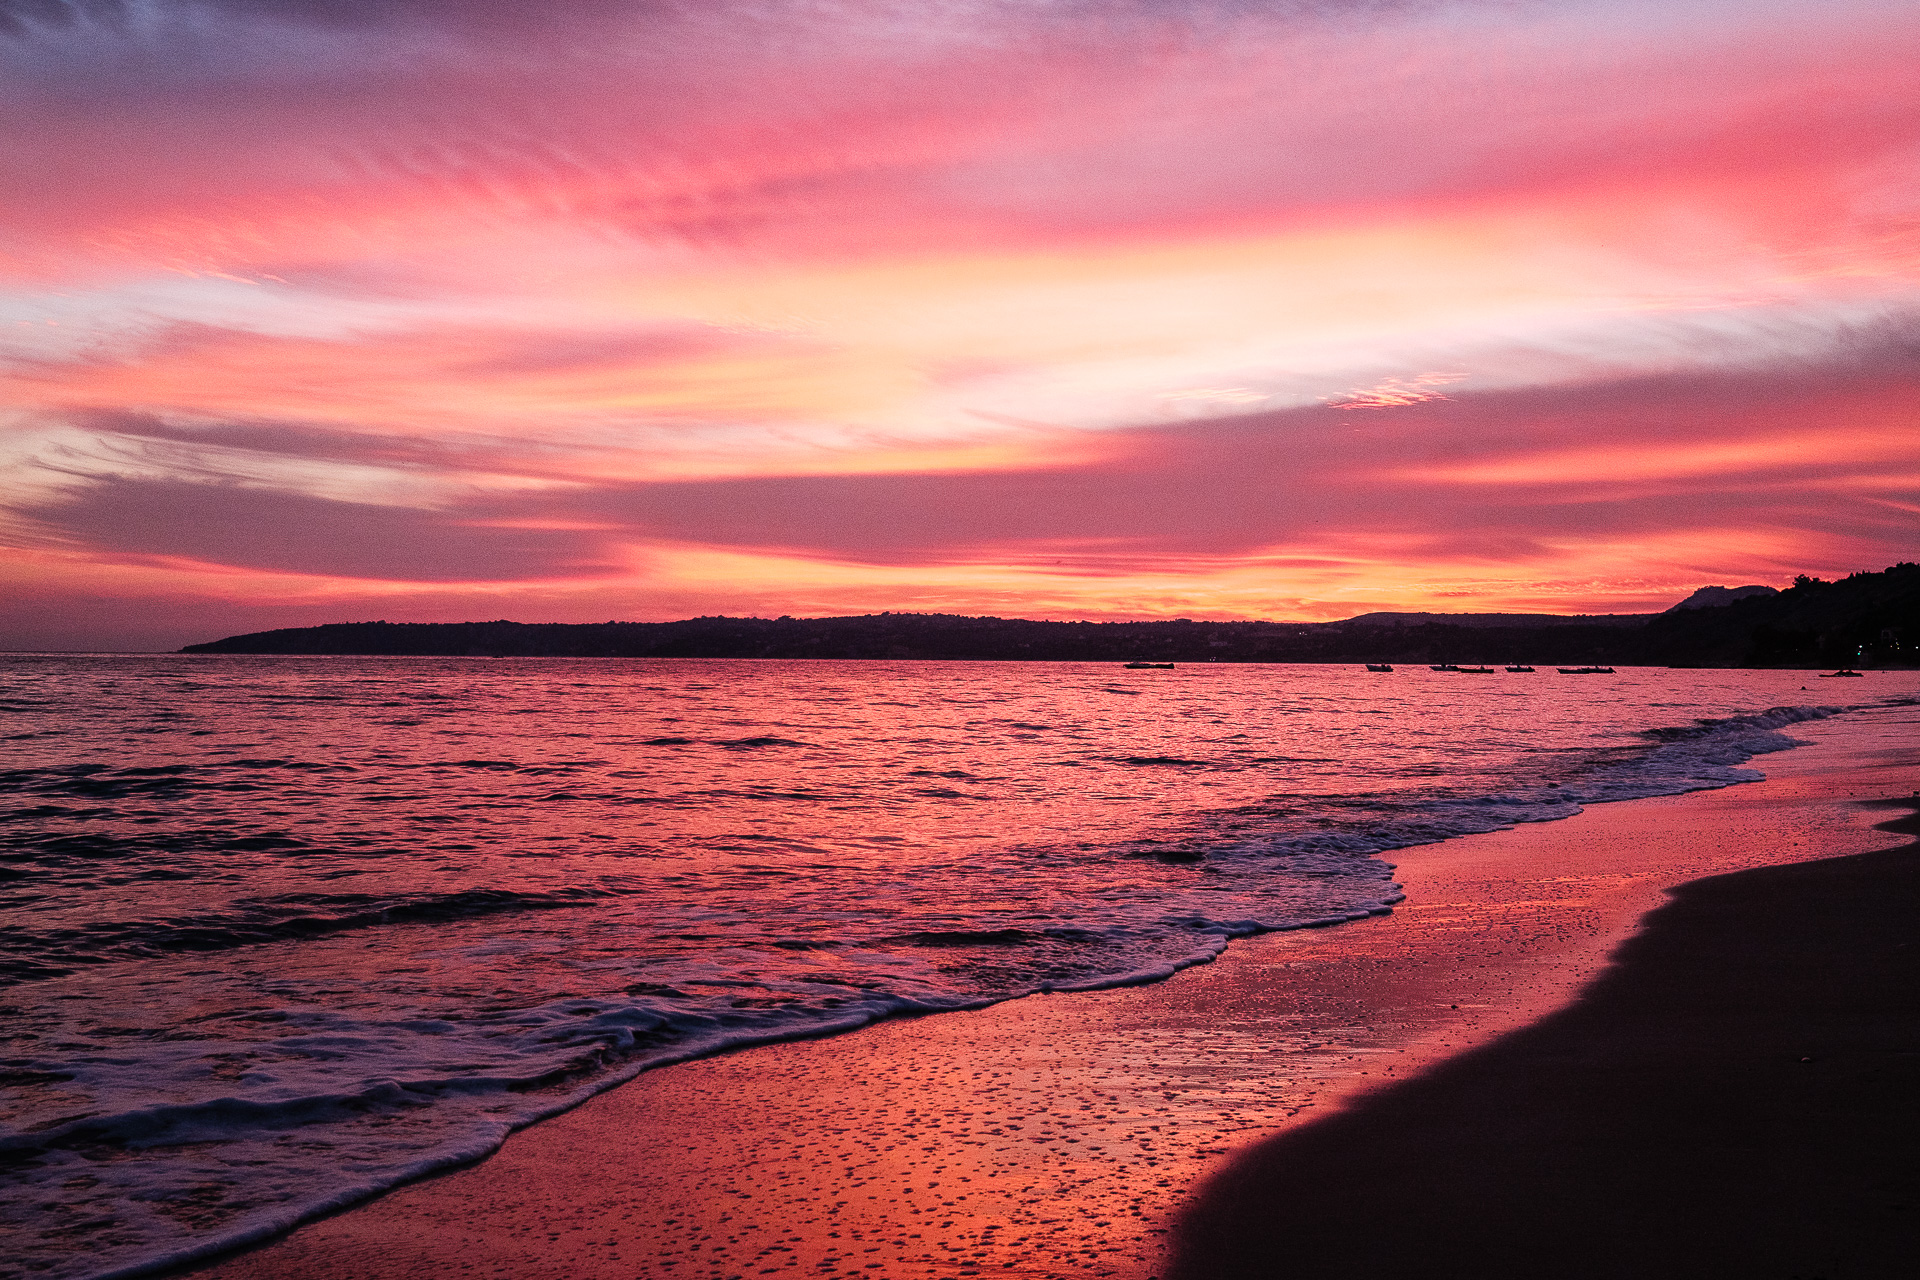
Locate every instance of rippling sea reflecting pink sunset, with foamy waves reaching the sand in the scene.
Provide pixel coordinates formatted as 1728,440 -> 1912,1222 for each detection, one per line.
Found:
0,654 -> 1896,1280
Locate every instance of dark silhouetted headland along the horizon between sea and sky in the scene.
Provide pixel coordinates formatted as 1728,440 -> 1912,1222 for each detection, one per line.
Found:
180,562 -> 1920,668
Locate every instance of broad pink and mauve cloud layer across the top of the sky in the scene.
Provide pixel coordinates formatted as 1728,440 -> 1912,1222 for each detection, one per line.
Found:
0,2 -> 1920,271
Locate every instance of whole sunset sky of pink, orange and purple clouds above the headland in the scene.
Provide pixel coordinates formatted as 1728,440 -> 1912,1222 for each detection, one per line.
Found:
0,0 -> 1920,649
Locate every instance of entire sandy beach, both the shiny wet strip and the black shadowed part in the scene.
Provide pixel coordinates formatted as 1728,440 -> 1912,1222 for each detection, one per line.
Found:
192,708 -> 1920,1280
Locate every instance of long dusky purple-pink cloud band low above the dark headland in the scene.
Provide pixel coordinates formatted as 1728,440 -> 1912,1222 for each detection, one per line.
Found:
27,334 -> 1920,594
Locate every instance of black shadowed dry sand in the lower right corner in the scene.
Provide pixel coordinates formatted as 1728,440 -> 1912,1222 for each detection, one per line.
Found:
1165,794 -> 1920,1280
